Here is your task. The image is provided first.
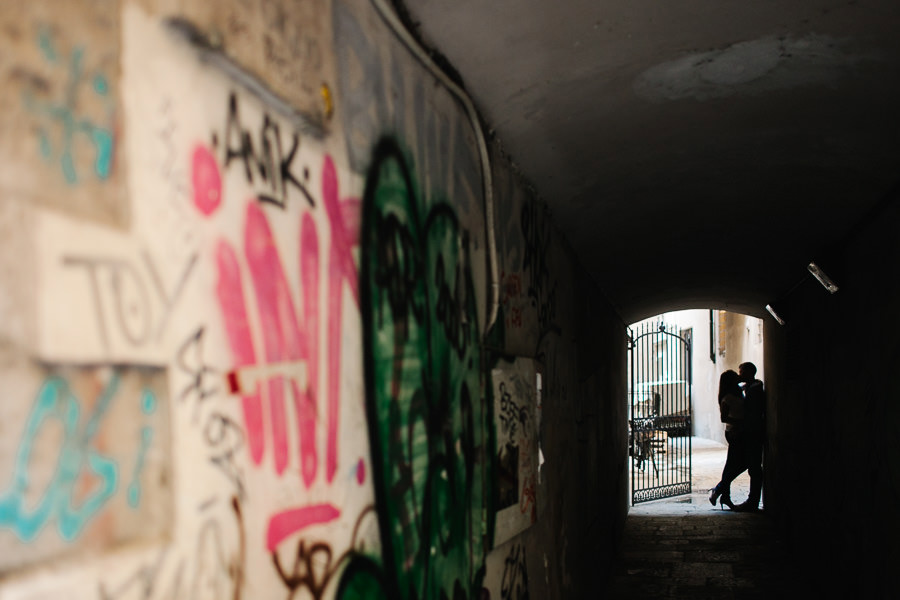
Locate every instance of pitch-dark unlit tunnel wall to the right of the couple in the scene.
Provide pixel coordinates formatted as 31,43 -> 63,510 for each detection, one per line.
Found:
764,186 -> 900,598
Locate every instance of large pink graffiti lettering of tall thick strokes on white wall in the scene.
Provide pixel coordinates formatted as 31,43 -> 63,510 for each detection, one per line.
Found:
216,156 -> 365,544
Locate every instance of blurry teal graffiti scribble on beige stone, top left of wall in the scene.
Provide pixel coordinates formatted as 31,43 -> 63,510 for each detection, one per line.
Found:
23,30 -> 114,184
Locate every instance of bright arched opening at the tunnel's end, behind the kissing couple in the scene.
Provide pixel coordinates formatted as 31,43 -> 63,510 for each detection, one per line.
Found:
625,309 -> 765,512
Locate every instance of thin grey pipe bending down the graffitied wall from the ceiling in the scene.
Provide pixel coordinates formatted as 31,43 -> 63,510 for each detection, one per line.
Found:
370,0 -> 500,333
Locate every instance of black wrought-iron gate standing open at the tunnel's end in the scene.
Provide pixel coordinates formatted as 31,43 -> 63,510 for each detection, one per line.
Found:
628,322 -> 691,505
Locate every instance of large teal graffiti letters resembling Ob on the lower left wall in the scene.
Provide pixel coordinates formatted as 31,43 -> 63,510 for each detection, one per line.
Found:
0,374 -> 119,542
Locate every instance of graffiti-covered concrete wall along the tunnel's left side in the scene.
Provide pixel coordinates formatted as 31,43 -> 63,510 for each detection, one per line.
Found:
0,0 -> 627,599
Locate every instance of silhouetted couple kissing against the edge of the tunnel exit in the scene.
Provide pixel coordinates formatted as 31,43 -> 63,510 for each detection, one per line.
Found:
709,363 -> 766,512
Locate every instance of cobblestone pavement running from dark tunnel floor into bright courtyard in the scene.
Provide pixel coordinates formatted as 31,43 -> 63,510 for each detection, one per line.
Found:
605,438 -> 803,600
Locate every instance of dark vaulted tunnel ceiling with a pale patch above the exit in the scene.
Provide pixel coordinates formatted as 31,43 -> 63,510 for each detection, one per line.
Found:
405,0 -> 900,322
